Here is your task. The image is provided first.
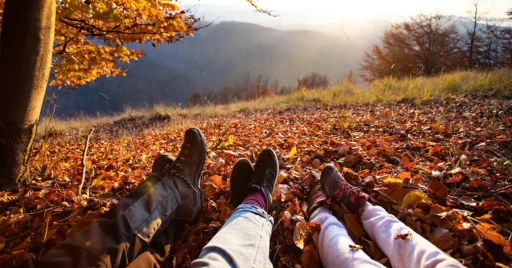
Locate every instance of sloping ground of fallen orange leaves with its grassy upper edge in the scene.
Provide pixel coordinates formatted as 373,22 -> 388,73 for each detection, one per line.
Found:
0,70 -> 512,267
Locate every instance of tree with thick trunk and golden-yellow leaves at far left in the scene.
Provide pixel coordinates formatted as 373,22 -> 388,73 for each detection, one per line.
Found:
0,0 -> 268,190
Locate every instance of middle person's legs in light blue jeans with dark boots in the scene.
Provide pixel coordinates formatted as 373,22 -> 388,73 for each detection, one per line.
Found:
192,149 -> 279,267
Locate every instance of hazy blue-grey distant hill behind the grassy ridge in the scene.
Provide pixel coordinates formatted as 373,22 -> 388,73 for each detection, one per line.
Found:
48,22 -> 367,116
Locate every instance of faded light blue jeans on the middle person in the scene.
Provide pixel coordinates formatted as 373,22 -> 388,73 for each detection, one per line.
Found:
192,204 -> 274,267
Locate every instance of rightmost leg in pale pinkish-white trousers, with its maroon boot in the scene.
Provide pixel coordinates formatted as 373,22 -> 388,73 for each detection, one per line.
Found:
320,165 -> 464,268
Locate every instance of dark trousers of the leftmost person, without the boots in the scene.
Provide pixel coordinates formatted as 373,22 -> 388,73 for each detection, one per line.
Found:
22,174 -> 181,267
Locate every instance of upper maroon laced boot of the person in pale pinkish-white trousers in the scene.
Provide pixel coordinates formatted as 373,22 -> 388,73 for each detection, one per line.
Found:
320,164 -> 368,214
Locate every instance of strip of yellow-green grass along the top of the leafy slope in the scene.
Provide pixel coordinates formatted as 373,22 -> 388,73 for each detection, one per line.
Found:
39,69 -> 512,134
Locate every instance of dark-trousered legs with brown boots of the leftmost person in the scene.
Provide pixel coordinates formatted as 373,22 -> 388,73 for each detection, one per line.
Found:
21,129 -> 206,267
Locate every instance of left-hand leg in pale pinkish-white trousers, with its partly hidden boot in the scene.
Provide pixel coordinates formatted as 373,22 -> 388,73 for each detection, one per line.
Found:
308,186 -> 384,268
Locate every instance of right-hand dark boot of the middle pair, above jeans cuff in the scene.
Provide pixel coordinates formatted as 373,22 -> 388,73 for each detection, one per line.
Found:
244,148 -> 279,213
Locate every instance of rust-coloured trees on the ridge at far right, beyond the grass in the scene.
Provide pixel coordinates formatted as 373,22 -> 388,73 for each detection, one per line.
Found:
361,13 -> 512,82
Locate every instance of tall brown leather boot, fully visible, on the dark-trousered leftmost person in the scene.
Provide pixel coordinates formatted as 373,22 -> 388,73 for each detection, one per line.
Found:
164,128 -> 206,222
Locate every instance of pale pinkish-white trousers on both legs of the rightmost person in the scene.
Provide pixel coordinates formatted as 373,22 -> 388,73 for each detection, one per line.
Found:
311,204 -> 464,268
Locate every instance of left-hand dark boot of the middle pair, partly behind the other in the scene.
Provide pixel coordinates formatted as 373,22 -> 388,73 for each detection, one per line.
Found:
229,158 -> 254,207
